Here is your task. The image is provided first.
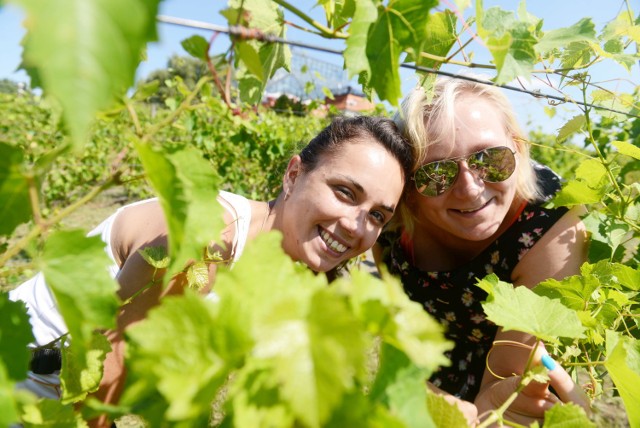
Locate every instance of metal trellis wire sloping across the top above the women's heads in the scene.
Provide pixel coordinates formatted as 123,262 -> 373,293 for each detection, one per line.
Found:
156,15 -> 640,118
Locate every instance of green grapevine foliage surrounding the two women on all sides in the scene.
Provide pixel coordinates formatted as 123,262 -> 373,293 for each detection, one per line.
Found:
0,0 -> 640,427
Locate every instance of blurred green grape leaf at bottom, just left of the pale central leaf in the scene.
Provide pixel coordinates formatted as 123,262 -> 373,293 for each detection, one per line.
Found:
121,290 -> 230,426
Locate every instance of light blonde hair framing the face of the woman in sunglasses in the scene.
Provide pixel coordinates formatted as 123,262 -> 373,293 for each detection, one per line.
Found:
394,75 -> 540,233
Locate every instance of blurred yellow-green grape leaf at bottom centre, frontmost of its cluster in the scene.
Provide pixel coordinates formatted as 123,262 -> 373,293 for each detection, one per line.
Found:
252,290 -> 365,427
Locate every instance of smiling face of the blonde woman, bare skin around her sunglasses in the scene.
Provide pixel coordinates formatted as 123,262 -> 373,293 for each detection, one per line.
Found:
411,95 -> 518,241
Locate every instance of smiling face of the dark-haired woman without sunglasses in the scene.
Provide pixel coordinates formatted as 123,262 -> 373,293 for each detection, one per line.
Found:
282,140 -> 404,272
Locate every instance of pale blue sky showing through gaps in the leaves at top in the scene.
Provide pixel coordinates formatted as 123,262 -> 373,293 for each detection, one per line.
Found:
0,0 -> 640,133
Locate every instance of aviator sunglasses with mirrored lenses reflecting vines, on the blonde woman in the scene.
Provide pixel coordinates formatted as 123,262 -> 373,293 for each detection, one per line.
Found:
413,147 -> 516,196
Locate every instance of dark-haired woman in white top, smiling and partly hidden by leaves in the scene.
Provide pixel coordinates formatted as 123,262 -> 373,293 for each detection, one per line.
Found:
11,116 -> 412,420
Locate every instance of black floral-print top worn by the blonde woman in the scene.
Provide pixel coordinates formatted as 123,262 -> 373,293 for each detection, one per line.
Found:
378,165 -> 567,401
